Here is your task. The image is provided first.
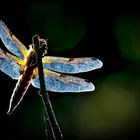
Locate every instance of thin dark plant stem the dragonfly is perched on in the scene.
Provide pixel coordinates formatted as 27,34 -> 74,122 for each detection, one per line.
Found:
32,35 -> 63,140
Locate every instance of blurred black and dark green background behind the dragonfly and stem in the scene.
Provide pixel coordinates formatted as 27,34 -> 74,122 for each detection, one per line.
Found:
0,0 -> 140,140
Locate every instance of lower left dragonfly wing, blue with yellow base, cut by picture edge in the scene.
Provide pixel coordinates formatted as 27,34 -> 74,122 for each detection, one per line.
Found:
0,49 -> 24,79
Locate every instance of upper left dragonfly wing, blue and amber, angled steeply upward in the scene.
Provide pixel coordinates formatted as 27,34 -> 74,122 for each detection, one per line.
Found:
0,21 -> 28,59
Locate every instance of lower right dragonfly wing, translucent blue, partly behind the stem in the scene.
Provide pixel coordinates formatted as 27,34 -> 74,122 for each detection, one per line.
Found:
31,69 -> 95,92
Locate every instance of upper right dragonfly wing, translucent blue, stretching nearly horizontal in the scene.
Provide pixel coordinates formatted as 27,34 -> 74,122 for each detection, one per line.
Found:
43,56 -> 103,73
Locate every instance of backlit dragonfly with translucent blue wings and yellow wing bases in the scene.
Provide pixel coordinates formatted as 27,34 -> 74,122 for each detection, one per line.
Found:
0,20 -> 103,114
